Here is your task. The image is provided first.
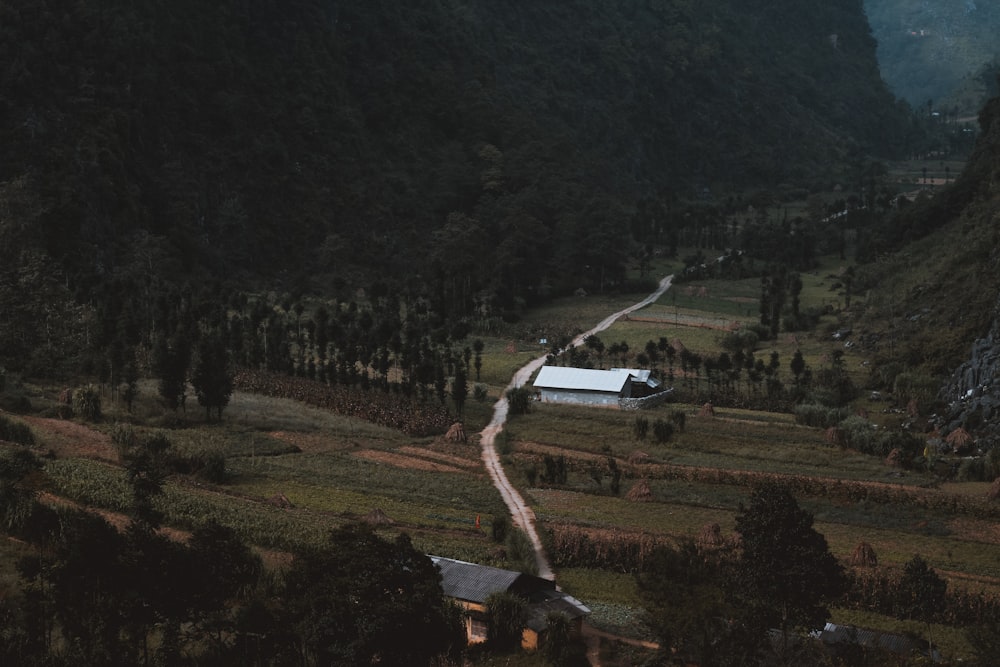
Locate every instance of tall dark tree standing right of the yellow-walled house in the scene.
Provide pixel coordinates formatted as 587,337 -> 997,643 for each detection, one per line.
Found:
736,483 -> 847,660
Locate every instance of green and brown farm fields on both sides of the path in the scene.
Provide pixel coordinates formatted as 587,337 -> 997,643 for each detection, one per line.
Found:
0,254 -> 1000,657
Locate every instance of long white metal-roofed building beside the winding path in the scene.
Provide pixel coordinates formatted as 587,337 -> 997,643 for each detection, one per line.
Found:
533,366 -> 659,406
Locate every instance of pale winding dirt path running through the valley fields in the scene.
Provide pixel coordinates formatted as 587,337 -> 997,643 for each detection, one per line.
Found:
479,275 -> 673,580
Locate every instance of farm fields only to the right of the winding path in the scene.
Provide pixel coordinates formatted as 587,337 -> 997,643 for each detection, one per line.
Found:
507,259 -> 1000,657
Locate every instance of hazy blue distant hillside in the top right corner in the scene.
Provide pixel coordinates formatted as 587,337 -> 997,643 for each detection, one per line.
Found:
865,0 -> 1000,114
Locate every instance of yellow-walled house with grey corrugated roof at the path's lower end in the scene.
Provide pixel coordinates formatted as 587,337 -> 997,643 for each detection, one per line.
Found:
431,556 -> 590,650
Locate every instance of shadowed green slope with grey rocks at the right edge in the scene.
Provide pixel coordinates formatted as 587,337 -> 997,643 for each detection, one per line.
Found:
854,98 -> 1000,437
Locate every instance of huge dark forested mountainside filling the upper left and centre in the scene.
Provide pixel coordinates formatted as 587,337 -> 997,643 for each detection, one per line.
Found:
0,0 -> 925,376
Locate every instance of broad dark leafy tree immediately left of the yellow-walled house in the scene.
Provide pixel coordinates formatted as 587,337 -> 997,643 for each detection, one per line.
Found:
285,524 -> 465,667
